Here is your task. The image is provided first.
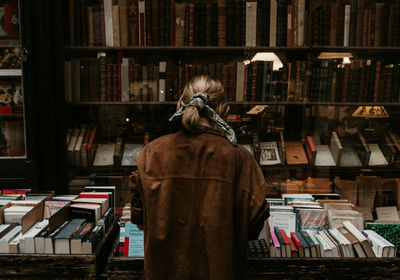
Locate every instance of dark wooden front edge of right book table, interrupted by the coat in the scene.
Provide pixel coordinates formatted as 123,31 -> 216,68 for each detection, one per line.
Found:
106,256 -> 400,280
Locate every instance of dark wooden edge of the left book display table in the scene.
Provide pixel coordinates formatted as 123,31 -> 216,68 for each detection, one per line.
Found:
0,220 -> 119,279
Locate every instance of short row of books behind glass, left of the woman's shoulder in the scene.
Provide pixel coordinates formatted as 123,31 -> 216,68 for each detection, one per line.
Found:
67,125 -> 144,167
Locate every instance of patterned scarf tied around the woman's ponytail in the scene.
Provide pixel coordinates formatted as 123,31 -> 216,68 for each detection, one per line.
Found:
169,92 -> 237,146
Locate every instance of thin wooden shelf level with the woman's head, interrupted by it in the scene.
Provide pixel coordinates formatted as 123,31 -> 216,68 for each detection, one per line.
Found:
67,101 -> 400,106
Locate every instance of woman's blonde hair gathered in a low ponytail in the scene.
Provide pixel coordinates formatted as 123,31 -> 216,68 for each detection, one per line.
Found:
178,75 -> 228,133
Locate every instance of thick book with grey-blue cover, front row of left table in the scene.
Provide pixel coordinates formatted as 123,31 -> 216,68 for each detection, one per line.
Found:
54,219 -> 85,255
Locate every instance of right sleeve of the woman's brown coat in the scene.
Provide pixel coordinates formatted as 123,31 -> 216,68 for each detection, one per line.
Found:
237,147 -> 269,240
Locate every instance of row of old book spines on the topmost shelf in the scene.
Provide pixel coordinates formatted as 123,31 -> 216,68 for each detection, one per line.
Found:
69,0 -> 400,47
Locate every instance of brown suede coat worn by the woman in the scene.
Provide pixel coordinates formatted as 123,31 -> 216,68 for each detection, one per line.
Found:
130,127 -> 269,280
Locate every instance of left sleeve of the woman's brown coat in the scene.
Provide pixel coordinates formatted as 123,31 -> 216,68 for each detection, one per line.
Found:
129,170 -> 143,226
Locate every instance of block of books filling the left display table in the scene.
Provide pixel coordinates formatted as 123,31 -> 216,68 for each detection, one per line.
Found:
0,186 -> 115,254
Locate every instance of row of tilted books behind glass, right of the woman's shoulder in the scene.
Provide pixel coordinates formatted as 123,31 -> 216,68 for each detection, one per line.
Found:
247,131 -> 400,167
